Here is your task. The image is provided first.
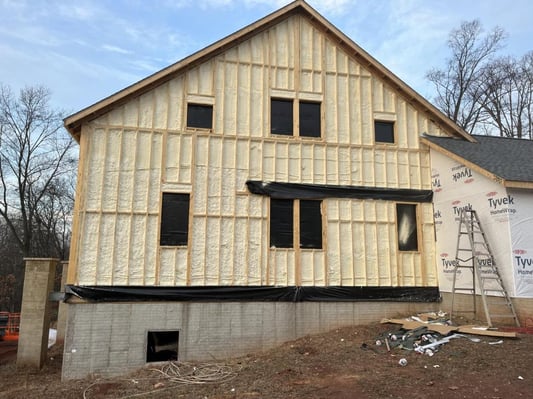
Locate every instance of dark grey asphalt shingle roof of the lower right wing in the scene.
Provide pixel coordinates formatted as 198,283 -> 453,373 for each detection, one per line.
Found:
423,135 -> 533,182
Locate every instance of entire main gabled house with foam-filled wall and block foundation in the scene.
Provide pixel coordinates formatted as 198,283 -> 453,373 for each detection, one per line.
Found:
63,0 -> 473,378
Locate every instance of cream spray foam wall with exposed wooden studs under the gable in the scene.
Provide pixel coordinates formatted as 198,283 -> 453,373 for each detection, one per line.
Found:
70,16 -> 442,286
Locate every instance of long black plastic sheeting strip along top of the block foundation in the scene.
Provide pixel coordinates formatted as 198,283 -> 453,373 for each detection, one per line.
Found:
65,285 -> 440,302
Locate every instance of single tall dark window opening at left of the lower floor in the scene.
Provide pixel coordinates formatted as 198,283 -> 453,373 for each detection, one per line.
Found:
159,193 -> 189,246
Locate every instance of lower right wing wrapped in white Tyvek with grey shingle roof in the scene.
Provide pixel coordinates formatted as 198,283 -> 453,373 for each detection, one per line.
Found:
421,135 -> 533,314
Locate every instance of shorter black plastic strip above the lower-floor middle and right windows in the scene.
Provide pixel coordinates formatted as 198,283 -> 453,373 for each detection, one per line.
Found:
246,180 -> 433,202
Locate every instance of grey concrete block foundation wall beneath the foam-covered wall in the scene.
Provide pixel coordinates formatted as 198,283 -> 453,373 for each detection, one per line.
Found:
62,302 -> 440,379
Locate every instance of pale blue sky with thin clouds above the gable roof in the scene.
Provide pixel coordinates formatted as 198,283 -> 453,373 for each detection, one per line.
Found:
0,0 -> 533,114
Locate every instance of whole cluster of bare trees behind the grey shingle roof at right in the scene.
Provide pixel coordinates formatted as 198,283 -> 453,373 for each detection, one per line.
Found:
426,20 -> 533,140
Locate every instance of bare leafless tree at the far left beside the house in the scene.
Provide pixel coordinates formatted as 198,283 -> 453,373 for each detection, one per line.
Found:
0,85 -> 75,257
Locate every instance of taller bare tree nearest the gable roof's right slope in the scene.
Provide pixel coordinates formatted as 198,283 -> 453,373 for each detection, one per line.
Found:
426,20 -> 505,132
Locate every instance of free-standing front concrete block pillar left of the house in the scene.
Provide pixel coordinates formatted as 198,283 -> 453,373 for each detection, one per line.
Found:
17,258 -> 59,369
